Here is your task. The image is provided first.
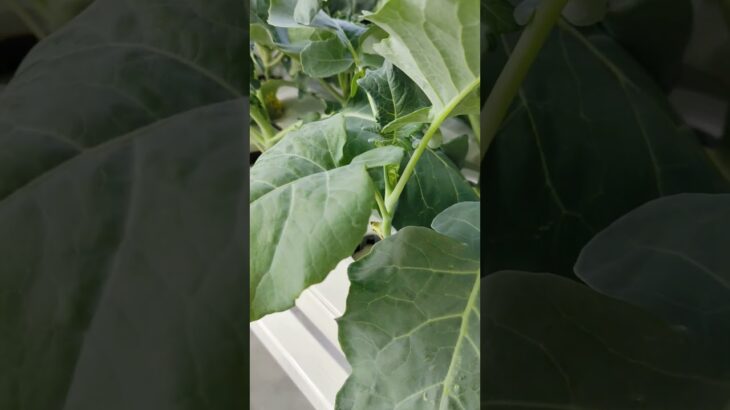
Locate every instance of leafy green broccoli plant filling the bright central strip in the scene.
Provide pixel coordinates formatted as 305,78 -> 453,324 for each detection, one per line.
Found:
249,0 -> 481,409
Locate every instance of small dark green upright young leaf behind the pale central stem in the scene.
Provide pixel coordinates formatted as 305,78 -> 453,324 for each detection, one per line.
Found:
358,61 -> 430,127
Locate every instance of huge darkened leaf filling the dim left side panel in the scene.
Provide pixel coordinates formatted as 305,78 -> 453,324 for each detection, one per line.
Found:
0,0 -> 248,410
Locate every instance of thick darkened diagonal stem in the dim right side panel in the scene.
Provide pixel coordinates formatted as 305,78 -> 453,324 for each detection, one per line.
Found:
481,0 -> 568,157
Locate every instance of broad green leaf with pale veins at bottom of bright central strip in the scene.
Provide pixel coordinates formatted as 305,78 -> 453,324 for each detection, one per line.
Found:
336,227 -> 480,410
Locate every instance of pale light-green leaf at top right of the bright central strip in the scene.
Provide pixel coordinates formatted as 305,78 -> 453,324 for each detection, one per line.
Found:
367,0 -> 480,113
